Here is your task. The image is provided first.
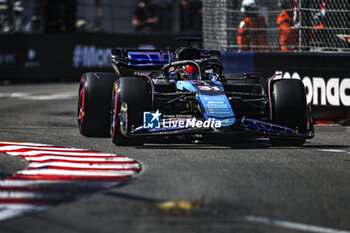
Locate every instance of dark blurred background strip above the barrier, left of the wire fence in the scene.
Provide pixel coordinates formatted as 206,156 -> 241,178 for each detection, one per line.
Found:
0,0 -> 202,34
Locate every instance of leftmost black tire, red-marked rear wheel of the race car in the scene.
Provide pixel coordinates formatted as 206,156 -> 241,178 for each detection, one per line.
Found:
78,72 -> 118,137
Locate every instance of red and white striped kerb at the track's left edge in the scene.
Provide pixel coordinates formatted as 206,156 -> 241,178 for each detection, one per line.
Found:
0,141 -> 141,221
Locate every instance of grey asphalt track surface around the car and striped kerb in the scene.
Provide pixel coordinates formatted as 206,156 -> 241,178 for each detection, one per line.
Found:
0,83 -> 350,233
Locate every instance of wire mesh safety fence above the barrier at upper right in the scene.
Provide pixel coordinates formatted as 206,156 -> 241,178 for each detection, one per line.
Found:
203,0 -> 350,52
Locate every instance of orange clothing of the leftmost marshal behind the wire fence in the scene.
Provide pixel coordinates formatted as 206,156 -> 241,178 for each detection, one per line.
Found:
237,16 -> 269,51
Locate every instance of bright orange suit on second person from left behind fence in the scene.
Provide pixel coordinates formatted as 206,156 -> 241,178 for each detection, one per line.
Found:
277,11 -> 299,51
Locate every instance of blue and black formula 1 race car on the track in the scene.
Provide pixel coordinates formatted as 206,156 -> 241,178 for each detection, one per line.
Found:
78,39 -> 314,146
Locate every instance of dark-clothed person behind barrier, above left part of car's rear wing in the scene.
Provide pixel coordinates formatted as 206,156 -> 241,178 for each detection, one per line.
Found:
131,0 -> 159,31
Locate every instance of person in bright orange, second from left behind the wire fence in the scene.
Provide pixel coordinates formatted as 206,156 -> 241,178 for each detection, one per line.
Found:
277,0 -> 299,51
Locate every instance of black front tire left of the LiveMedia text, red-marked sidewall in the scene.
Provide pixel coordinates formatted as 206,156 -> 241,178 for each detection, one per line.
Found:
110,77 -> 152,146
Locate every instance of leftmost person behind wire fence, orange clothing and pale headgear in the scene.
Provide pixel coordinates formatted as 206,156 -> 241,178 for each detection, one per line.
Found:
237,0 -> 269,51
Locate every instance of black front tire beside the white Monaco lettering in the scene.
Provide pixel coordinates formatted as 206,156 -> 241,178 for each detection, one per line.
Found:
270,79 -> 307,146
